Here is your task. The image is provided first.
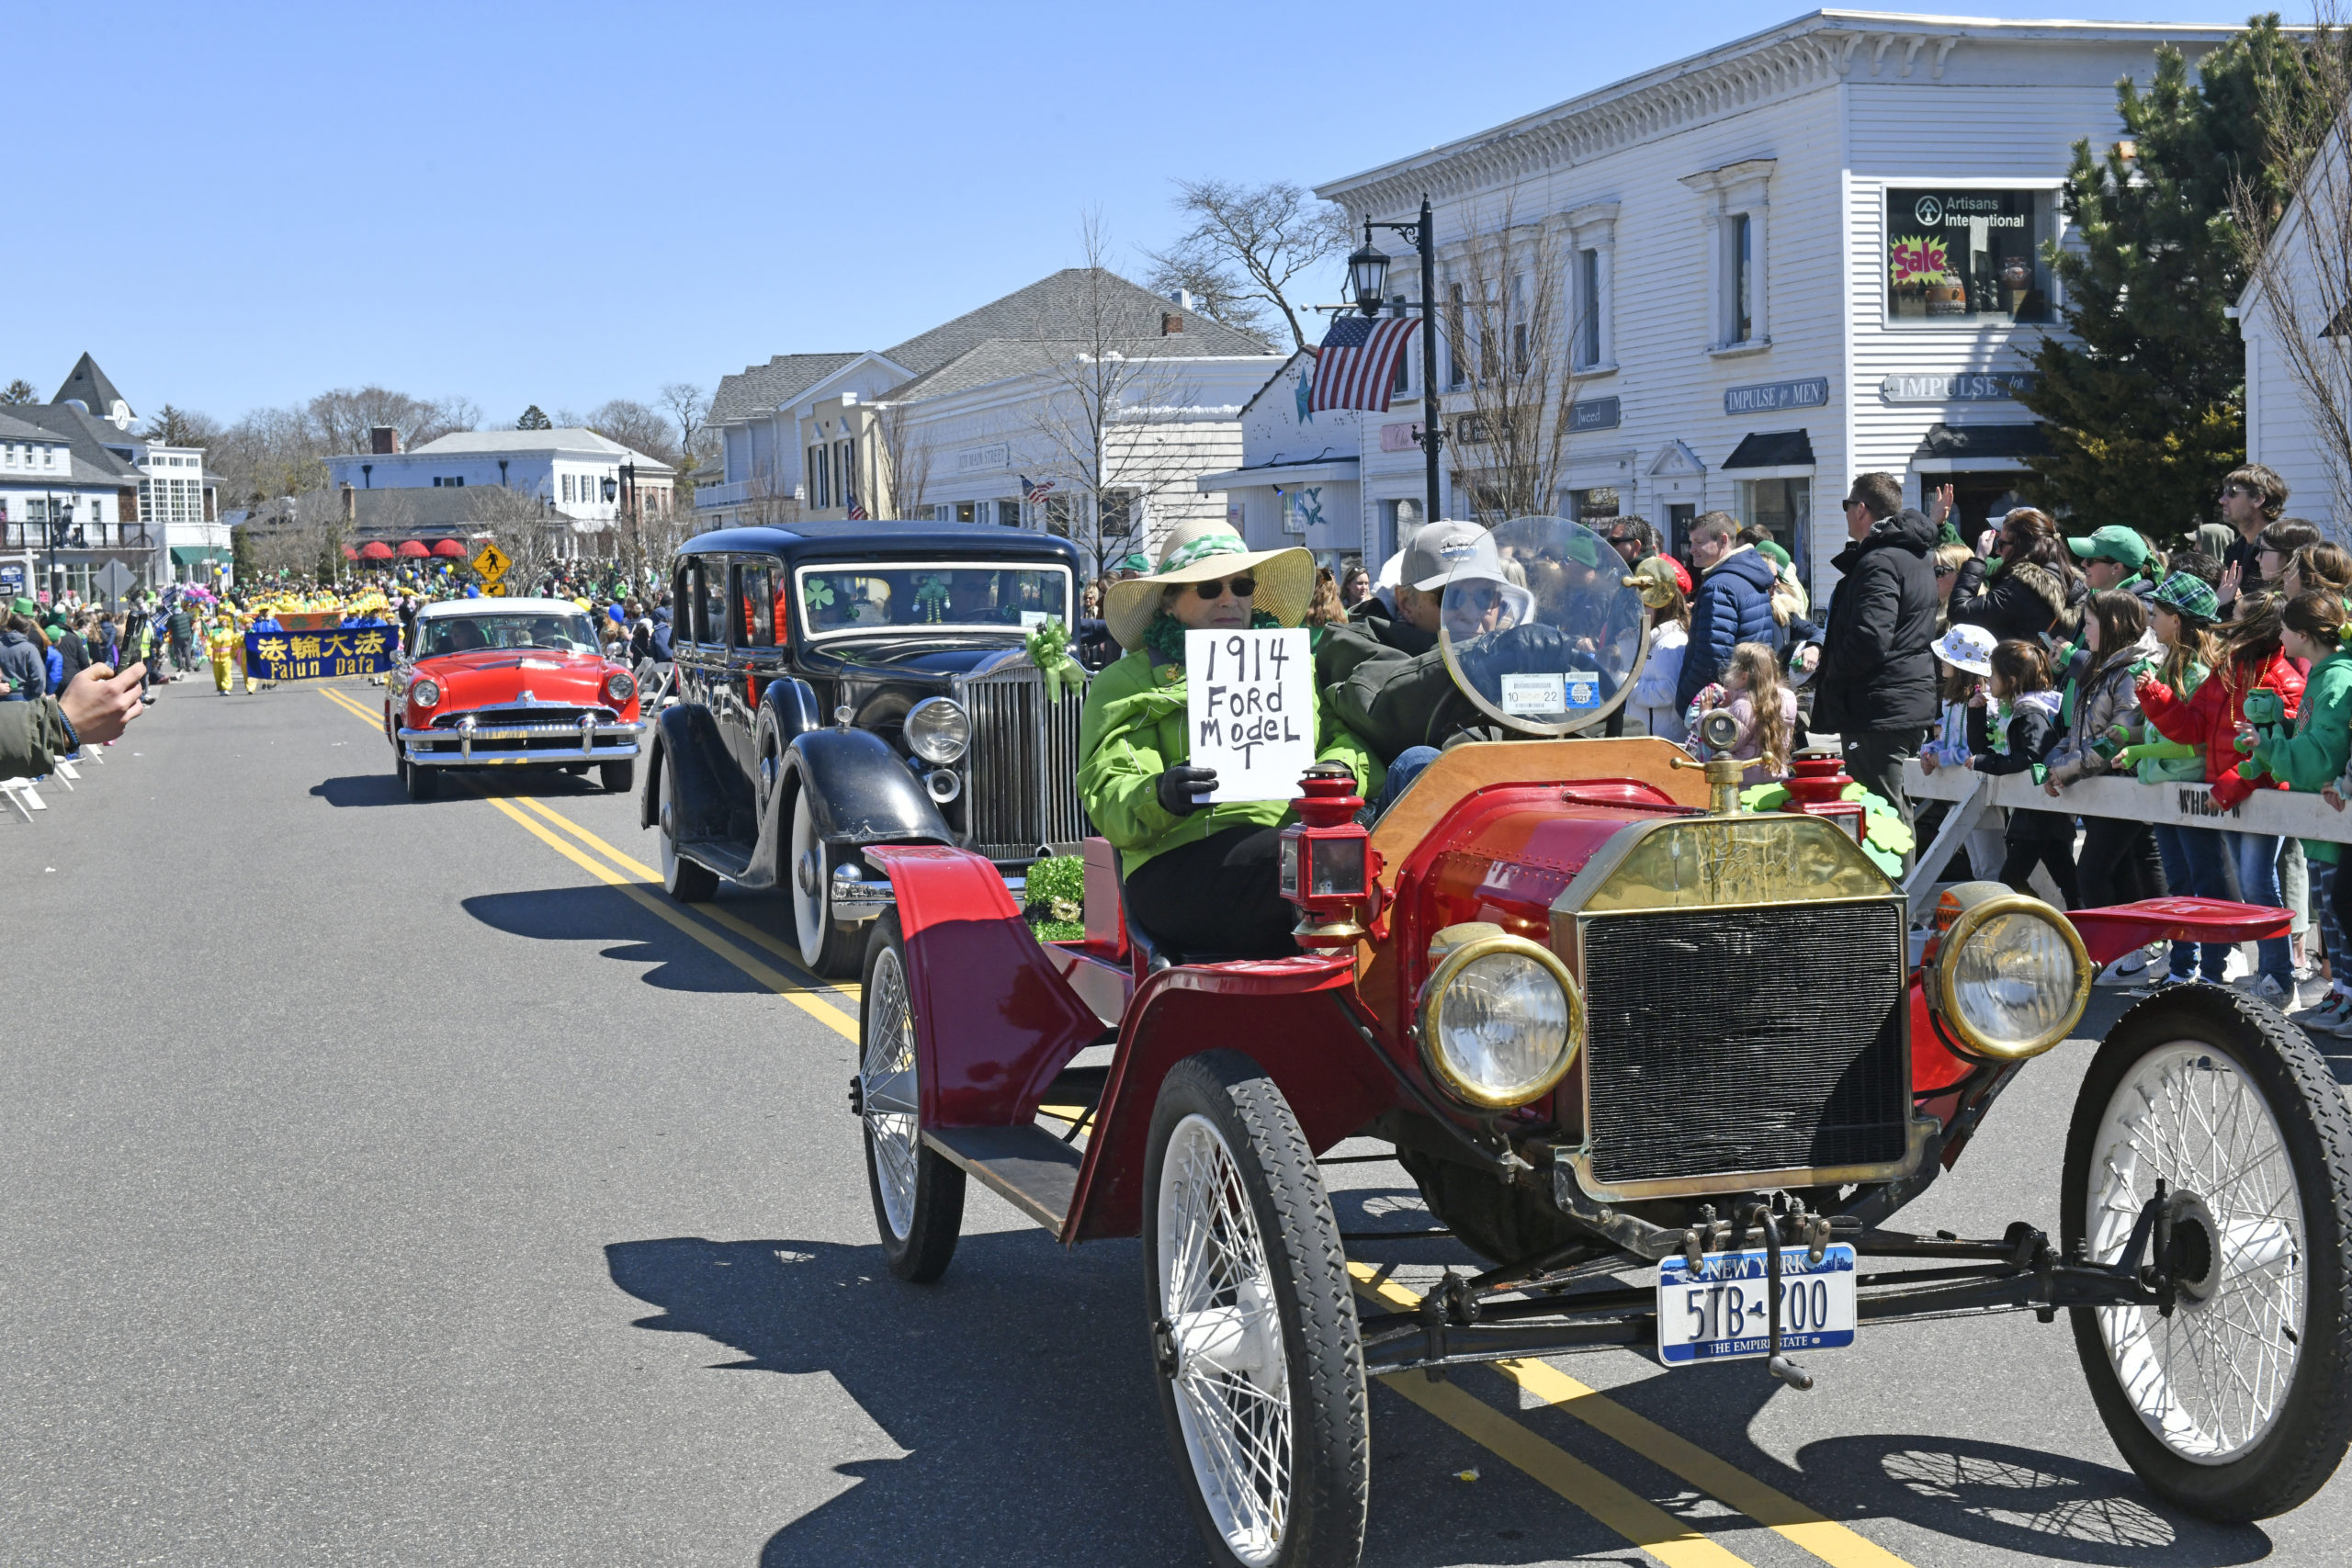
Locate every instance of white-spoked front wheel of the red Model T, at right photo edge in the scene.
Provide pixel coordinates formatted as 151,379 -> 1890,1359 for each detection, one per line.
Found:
2063,985 -> 2352,1521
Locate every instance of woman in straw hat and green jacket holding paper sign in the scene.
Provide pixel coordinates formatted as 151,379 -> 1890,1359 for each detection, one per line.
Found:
1077,522 -> 1381,957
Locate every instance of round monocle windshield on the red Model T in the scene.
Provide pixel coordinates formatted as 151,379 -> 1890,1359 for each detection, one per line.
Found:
1440,517 -> 1646,736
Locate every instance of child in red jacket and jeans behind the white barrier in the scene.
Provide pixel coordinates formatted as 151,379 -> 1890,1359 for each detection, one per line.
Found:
2138,592 -> 2302,1009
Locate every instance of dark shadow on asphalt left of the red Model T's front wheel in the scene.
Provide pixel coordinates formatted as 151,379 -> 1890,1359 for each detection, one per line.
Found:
605,1232 -> 1202,1568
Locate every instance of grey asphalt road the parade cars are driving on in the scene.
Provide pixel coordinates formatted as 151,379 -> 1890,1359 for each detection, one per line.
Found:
0,682 -> 2352,1568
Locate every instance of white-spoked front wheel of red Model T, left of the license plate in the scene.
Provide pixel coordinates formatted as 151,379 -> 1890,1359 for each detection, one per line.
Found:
1143,1051 -> 1371,1568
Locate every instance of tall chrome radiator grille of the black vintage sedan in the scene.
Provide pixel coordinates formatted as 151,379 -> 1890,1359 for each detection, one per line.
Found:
957,653 -> 1093,861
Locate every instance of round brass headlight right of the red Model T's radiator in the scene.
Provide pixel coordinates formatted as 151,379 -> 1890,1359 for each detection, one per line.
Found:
1928,884 -> 2098,1063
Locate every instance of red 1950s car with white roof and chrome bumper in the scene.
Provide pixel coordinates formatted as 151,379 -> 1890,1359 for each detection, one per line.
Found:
383,600 -> 644,799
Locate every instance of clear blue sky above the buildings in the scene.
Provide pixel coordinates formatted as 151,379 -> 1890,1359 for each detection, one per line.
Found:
14,0 -> 2244,423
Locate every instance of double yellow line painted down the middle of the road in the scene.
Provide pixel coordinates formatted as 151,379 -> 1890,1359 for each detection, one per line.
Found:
320,686 -> 1910,1568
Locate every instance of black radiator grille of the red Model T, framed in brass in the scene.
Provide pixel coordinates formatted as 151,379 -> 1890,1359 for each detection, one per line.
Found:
1580,900 -> 1910,1194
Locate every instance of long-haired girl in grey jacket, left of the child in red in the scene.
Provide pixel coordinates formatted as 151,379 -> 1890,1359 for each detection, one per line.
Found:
2041,588 -> 2164,907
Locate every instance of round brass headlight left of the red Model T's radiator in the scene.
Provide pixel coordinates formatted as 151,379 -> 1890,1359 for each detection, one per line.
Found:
1420,924 -> 1585,1110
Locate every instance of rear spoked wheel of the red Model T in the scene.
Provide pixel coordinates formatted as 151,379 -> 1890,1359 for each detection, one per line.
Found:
856,915 -> 965,1283
